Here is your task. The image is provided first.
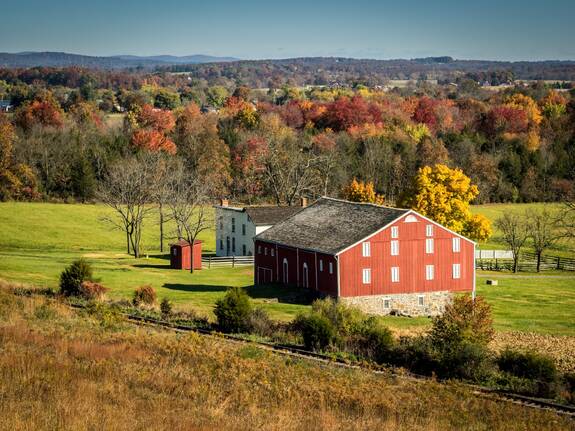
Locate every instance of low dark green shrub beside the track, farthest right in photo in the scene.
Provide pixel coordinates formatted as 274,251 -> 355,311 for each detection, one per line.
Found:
497,349 -> 557,383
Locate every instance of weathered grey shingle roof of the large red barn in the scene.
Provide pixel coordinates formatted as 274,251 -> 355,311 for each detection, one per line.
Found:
255,197 -> 409,254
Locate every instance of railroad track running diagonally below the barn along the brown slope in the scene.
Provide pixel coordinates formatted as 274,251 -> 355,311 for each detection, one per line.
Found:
113,312 -> 575,419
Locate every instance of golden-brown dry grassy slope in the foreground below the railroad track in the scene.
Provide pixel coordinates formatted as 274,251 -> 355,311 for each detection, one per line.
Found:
0,289 -> 572,431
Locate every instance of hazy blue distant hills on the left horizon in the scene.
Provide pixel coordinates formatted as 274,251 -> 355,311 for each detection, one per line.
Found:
0,52 -> 238,69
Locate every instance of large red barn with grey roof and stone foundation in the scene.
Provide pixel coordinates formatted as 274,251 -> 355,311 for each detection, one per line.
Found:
254,197 -> 475,315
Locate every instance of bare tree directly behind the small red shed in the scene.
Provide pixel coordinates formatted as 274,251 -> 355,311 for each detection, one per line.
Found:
167,164 -> 213,273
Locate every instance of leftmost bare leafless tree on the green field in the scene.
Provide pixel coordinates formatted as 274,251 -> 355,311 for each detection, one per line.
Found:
98,156 -> 154,258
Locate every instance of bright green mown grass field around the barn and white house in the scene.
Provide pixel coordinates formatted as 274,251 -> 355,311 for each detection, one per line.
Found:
0,203 -> 575,335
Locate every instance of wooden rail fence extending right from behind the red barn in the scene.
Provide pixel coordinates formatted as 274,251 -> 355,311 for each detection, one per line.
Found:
475,250 -> 575,272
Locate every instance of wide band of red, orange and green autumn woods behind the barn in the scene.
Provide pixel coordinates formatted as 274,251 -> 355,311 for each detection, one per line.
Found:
0,77 -> 575,204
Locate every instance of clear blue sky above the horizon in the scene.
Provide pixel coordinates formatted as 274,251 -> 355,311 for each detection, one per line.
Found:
0,0 -> 575,60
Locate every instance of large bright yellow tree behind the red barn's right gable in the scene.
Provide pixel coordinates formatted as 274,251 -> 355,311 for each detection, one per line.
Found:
400,164 -> 492,241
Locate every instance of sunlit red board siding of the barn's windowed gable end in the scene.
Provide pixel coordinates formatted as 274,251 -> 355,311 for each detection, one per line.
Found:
339,215 -> 474,297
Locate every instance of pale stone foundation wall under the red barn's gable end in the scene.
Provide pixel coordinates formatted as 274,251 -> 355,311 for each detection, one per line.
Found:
339,291 -> 452,316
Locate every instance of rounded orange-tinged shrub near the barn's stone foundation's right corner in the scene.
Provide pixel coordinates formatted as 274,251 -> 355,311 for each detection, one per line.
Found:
431,295 -> 494,348
